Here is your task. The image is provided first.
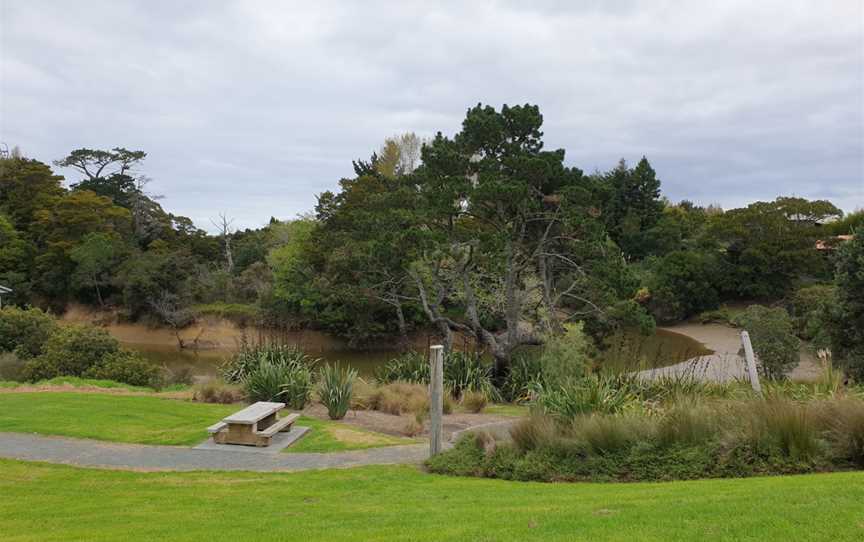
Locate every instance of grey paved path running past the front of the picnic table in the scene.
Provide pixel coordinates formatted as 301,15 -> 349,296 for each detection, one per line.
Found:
0,433 -> 429,472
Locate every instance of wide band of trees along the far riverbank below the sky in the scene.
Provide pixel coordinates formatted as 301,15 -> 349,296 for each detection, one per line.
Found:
0,105 -> 864,374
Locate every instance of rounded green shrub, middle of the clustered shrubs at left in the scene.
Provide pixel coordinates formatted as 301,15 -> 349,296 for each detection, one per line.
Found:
24,325 -> 120,382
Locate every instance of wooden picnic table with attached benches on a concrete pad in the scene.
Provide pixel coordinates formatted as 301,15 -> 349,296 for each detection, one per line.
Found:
207,401 -> 300,446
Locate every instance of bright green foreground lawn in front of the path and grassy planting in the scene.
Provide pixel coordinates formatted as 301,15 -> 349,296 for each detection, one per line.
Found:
0,460 -> 864,542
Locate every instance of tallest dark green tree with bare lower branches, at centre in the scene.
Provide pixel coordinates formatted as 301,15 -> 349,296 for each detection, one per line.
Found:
411,105 -> 612,376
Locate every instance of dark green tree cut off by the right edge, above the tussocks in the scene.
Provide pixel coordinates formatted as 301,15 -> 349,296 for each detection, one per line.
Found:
831,235 -> 864,382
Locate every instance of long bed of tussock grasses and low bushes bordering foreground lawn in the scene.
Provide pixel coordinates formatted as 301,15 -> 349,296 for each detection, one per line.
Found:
427,398 -> 864,481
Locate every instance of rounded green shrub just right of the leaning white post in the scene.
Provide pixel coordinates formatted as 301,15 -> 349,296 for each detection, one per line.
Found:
733,305 -> 801,380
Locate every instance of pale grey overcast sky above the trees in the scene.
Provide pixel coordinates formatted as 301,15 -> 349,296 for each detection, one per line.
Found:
0,0 -> 864,229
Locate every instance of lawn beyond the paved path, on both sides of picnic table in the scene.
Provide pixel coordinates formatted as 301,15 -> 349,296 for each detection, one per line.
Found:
0,392 -> 417,453
